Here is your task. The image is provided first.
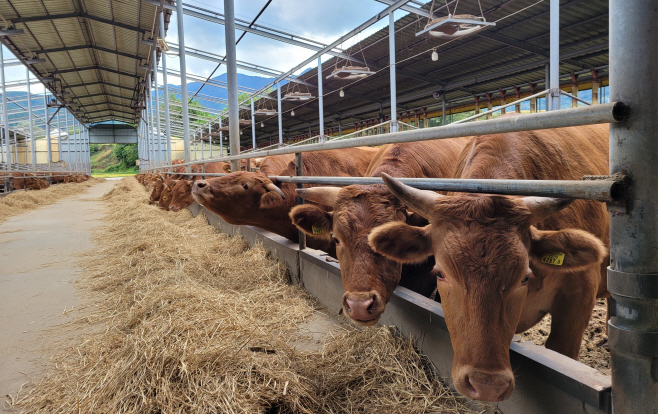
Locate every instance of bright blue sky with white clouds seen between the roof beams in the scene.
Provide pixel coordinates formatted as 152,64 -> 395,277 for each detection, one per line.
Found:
2,0 -> 406,105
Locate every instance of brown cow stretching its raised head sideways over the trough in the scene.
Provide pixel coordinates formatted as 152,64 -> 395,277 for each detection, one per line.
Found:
187,148 -> 377,253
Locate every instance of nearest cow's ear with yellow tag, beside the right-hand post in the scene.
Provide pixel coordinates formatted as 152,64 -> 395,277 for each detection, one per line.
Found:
530,227 -> 607,272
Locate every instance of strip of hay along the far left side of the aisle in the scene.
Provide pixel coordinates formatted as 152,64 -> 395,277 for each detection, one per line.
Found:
0,178 -> 105,224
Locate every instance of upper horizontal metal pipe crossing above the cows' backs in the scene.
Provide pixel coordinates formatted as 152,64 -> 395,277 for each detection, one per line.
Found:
159,102 -> 628,167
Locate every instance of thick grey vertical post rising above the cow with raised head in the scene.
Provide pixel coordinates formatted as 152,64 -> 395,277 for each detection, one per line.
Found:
224,0 -> 240,171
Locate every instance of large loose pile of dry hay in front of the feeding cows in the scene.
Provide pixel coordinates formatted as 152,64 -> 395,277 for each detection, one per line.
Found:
14,178 -> 471,413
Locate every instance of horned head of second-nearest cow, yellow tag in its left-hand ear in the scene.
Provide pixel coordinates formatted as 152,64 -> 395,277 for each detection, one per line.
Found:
290,184 -> 422,326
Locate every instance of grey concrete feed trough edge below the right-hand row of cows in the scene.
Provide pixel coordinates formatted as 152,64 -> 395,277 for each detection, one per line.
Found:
184,204 -> 612,414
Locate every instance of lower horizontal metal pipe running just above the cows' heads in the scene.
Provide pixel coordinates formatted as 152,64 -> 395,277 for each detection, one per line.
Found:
156,173 -> 623,202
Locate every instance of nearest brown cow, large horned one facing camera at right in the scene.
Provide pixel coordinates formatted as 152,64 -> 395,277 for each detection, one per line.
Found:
369,125 -> 609,401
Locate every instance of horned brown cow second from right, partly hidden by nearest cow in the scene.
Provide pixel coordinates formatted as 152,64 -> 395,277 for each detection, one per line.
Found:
290,138 -> 467,326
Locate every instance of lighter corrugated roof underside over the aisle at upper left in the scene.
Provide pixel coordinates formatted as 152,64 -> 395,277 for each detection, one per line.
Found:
0,0 -> 171,124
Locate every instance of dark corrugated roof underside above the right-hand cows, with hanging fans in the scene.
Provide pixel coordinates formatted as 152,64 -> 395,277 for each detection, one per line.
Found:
249,0 -> 608,146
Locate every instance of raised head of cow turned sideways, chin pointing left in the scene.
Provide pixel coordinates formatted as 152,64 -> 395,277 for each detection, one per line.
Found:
187,171 -> 286,224
